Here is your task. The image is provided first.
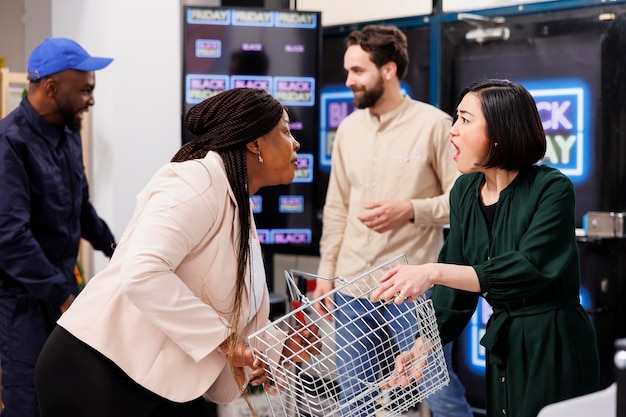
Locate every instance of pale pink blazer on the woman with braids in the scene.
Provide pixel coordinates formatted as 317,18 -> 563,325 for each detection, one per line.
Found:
58,152 -> 281,403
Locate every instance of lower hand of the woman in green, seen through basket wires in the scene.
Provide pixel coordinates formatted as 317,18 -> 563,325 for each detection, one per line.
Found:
379,337 -> 432,390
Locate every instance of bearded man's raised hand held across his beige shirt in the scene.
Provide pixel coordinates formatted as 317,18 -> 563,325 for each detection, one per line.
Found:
357,200 -> 413,233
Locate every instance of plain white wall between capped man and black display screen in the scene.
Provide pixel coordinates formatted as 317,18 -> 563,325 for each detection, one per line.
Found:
51,0 -> 190,271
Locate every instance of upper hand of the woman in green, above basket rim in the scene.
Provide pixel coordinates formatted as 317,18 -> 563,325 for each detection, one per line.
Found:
370,264 -> 438,304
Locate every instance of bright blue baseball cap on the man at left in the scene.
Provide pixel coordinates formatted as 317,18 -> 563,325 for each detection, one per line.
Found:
28,38 -> 113,81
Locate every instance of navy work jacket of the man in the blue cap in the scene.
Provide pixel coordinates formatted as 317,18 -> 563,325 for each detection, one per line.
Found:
0,98 -> 114,307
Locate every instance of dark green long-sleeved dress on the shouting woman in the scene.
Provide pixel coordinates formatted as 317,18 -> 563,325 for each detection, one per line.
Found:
432,166 -> 599,417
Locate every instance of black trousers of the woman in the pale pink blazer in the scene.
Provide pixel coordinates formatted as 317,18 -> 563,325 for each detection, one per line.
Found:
35,326 -> 211,417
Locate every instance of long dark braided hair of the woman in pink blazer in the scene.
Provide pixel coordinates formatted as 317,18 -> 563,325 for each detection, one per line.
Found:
172,88 -> 283,391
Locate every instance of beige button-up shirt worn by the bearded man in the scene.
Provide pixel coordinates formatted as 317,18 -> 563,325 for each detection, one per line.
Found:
318,96 -> 459,294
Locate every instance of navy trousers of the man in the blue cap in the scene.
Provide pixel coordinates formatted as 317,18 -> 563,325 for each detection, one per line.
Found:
0,285 -> 56,417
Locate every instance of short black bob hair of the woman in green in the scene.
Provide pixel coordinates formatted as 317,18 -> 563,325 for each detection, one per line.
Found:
455,79 -> 546,171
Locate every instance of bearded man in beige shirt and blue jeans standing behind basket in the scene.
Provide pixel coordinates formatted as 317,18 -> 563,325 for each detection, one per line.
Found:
313,26 -> 471,417
